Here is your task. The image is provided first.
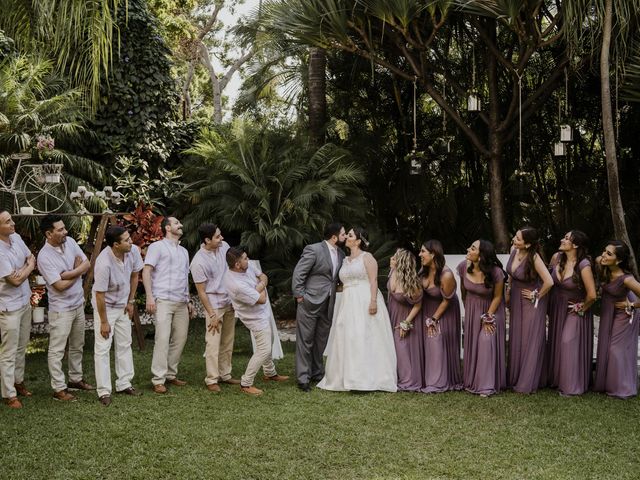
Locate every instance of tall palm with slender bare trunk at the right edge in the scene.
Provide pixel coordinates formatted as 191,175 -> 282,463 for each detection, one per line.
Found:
563,0 -> 640,275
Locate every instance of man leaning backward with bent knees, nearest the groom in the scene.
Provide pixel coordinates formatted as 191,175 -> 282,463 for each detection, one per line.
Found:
224,247 -> 289,396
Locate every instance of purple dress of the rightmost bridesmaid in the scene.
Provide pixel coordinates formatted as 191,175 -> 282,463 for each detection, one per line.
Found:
593,274 -> 640,398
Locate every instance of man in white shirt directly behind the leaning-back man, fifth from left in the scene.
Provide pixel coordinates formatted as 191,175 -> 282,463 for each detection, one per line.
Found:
191,223 -> 240,392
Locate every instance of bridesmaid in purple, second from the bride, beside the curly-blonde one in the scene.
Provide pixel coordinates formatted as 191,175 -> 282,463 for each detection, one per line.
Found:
419,240 -> 462,393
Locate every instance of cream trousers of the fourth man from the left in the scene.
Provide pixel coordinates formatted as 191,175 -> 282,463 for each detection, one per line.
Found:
151,299 -> 189,385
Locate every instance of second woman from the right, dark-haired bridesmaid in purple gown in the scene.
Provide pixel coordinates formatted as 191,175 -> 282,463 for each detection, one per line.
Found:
547,230 -> 596,396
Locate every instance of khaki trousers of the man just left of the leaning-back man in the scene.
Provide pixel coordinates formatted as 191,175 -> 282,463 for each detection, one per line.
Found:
204,305 -> 236,385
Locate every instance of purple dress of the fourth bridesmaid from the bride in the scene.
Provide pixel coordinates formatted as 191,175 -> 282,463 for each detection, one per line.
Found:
507,250 -> 549,393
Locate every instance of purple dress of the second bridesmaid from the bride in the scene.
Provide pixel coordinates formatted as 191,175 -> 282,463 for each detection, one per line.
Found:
422,269 -> 462,393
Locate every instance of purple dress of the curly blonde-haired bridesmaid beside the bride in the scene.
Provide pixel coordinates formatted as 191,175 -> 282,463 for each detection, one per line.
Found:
387,281 -> 424,392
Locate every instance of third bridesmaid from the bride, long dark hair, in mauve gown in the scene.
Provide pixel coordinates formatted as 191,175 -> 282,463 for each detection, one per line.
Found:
458,240 -> 507,397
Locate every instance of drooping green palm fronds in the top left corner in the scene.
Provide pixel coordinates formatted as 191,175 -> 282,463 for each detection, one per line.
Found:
0,0 -> 127,111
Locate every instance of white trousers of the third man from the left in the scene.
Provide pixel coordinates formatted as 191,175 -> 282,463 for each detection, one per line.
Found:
93,308 -> 133,398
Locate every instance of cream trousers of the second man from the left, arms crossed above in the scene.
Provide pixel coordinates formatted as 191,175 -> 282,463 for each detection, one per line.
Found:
47,306 -> 86,392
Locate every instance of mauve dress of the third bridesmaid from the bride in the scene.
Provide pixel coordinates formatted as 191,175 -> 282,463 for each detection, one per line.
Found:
458,260 -> 507,395
